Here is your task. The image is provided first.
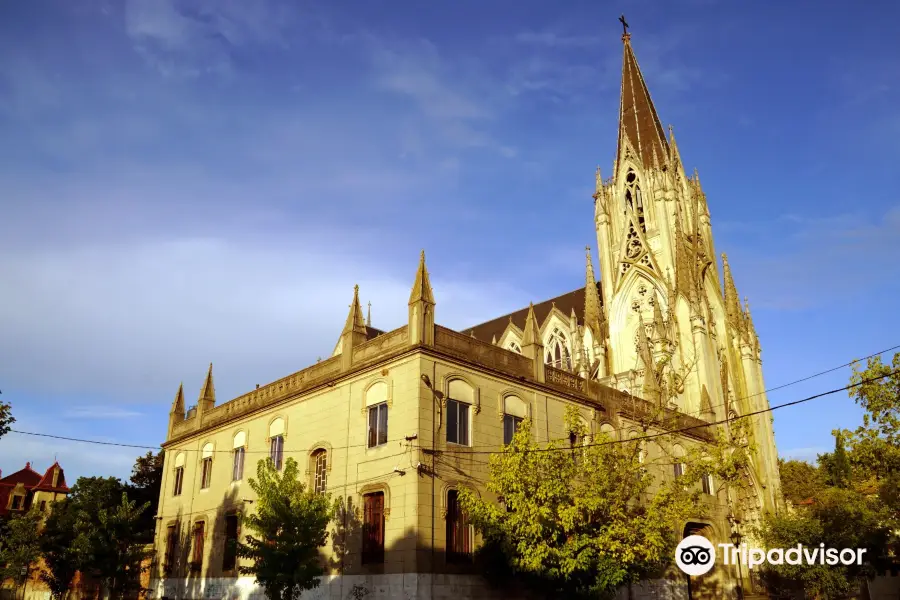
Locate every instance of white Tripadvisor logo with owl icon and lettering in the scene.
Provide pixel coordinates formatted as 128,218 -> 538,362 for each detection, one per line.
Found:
675,535 -> 866,575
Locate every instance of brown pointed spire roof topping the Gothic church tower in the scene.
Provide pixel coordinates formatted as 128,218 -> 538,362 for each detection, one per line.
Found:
616,23 -> 670,169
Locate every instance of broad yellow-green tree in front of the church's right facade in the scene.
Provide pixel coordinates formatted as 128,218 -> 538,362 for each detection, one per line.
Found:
460,412 -> 746,598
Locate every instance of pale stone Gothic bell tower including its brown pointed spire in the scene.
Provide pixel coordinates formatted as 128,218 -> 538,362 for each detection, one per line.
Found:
594,21 -> 780,506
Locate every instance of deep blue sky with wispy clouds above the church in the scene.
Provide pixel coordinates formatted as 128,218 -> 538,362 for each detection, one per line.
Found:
0,0 -> 900,479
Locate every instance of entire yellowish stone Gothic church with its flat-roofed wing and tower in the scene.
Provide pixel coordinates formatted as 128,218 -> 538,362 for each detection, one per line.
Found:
151,21 -> 782,600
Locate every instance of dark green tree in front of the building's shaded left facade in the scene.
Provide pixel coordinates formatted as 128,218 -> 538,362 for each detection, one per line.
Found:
238,458 -> 333,600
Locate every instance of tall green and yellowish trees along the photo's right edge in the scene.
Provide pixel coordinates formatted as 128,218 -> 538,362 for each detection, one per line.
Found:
760,353 -> 900,599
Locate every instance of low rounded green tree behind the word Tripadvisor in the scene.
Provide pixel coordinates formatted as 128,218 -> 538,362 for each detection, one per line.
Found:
759,487 -> 890,600
